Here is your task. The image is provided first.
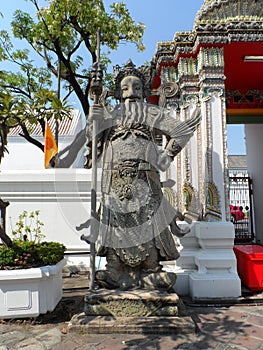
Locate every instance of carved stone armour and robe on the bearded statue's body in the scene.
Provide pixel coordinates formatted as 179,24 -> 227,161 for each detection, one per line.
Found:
98,104 -> 182,266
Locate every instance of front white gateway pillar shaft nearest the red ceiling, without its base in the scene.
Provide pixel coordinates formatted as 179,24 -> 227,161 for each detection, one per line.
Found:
198,48 -> 228,221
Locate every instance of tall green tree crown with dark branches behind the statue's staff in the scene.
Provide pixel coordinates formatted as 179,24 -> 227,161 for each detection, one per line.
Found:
0,0 -> 145,161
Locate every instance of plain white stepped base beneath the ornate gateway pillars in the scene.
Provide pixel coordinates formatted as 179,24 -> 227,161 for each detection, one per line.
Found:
174,222 -> 241,300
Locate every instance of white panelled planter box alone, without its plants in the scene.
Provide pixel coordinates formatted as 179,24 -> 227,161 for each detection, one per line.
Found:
0,259 -> 66,319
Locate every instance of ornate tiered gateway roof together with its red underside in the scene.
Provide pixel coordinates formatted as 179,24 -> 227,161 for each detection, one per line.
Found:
153,0 -> 263,115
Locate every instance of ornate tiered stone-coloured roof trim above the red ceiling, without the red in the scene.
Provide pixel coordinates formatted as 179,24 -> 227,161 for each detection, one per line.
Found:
154,0 -> 263,67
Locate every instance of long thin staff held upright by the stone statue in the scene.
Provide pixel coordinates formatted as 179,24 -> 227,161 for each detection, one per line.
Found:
90,29 -> 102,290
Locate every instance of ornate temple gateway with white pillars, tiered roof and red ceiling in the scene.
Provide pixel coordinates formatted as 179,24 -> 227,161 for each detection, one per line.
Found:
151,0 -> 263,298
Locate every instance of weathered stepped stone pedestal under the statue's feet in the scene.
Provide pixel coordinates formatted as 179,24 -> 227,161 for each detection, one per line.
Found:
68,290 -> 195,334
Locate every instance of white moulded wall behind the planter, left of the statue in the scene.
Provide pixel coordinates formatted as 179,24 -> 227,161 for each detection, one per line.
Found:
0,169 -> 94,266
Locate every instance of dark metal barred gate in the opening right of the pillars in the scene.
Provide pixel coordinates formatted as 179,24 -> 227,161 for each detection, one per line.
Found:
229,176 -> 255,243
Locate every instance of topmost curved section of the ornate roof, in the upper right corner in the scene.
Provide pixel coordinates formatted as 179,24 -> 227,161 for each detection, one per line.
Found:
194,0 -> 263,29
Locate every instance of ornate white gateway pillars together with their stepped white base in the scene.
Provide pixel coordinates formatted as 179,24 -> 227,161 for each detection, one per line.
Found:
161,48 -> 241,299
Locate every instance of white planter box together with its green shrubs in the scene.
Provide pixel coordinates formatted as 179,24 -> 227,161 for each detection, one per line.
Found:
0,210 -> 66,319
